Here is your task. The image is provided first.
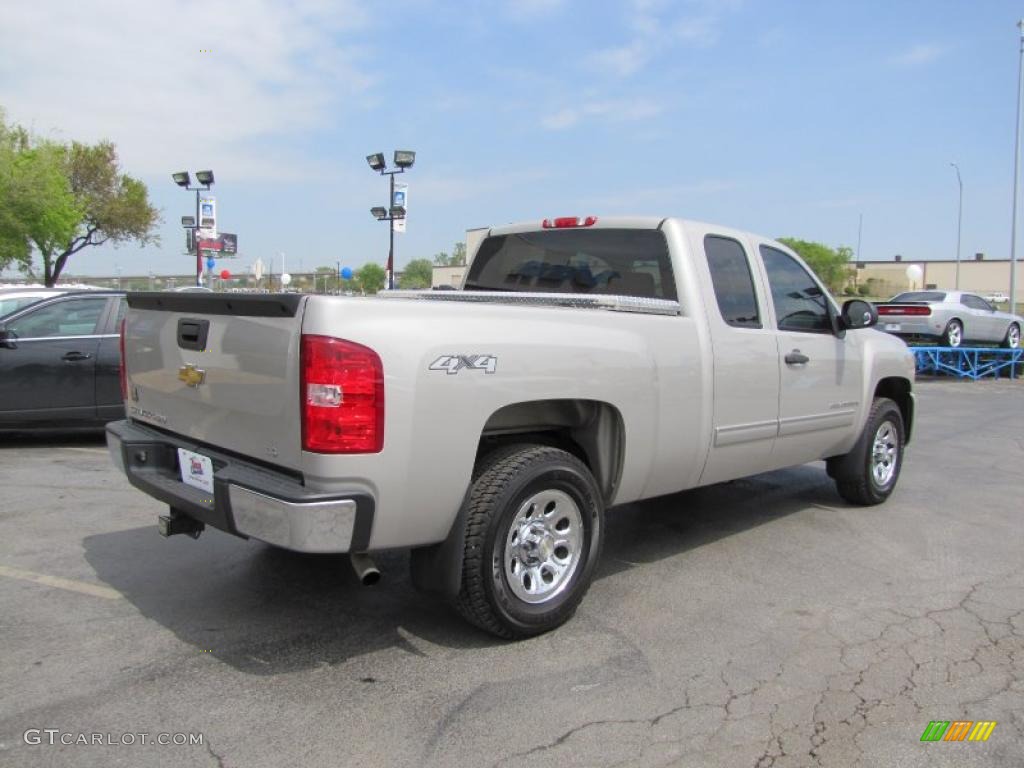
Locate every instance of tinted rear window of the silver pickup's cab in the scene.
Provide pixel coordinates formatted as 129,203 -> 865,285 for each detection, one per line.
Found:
465,229 -> 676,300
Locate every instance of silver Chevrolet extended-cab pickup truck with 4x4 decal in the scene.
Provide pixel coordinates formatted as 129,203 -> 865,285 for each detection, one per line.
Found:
106,216 -> 914,637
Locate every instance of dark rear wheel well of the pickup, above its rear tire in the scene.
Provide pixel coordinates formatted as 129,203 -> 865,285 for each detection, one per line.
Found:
476,399 -> 625,504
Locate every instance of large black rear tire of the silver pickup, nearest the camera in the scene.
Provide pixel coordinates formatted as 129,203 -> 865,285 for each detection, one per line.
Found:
454,444 -> 604,639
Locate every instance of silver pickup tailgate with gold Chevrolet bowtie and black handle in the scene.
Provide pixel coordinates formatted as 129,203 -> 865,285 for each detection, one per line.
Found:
124,293 -> 306,469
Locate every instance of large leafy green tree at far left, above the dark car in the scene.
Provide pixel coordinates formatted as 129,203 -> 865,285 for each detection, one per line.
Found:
0,115 -> 160,286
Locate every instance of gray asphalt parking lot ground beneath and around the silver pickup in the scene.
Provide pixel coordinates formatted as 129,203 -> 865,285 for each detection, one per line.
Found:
0,381 -> 1024,768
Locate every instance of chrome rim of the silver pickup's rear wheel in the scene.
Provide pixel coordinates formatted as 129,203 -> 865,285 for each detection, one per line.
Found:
505,488 -> 585,605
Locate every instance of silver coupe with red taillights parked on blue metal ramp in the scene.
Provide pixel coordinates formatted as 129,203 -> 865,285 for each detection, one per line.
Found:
878,291 -> 1024,349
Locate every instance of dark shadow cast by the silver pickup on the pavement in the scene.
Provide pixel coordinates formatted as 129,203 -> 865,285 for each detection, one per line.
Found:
83,465 -> 845,675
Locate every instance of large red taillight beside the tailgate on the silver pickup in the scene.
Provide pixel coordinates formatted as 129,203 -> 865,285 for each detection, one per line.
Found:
301,335 -> 384,454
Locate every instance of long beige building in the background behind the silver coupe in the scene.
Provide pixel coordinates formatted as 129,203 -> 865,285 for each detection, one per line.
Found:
851,254 -> 1011,298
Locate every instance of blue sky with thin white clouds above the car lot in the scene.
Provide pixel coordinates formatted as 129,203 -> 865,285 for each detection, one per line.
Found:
0,0 -> 1024,274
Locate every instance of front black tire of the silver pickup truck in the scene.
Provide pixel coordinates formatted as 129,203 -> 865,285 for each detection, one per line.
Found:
828,397 -> 905,507
